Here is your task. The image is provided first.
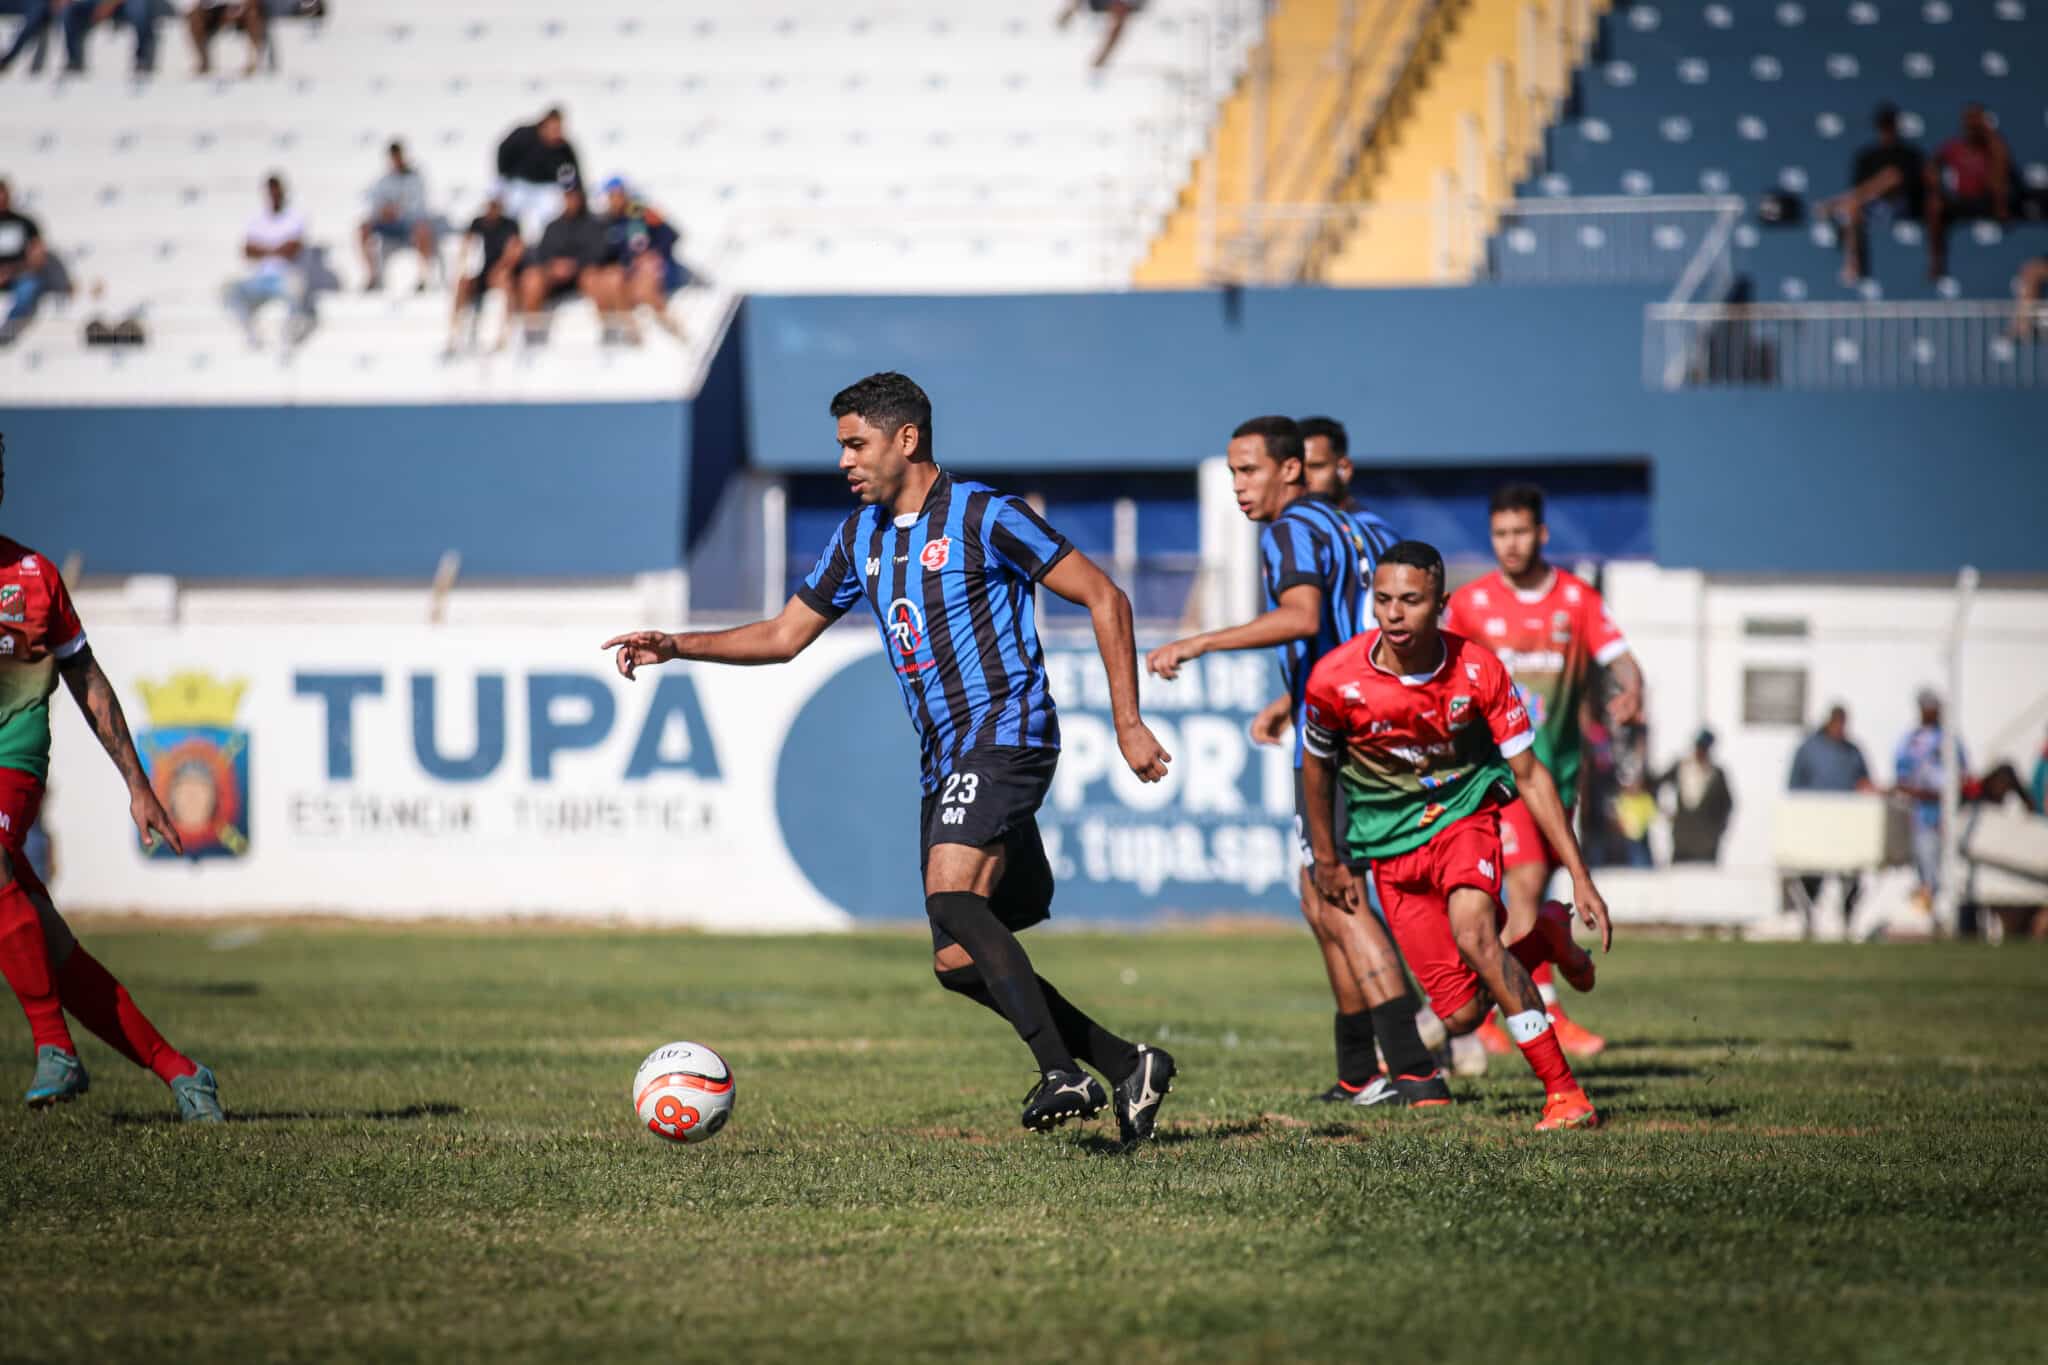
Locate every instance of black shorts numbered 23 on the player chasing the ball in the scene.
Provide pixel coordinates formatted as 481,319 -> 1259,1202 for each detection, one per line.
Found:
918,745 -> 1059,952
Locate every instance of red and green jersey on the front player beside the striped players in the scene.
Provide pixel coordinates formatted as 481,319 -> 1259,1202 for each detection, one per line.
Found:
1303,630 -> 1536,857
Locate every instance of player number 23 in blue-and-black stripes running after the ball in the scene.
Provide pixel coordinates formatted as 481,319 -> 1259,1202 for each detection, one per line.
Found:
604,375 -> 1176,1142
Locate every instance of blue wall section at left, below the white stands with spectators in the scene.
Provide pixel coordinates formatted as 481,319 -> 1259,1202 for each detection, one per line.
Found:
0,401 -> 690,579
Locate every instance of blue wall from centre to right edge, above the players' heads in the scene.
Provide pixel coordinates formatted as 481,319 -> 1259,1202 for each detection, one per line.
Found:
743,289 -> 2048,573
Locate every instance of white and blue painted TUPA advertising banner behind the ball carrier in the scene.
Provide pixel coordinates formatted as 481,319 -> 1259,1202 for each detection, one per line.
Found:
45,620 -> 1294,931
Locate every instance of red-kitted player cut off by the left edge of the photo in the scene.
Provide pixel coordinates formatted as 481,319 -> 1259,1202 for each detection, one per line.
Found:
0,442 -> 225,1124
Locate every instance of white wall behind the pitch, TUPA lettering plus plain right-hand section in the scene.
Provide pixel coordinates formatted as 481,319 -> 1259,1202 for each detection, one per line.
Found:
45,565 -> 2048,931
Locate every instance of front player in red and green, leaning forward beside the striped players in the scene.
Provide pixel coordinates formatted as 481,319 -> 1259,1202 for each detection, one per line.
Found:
1303,540 -> 1614,1130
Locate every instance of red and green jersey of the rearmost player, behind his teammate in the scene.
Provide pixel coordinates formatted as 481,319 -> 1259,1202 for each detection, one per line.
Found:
1444,569 -> 1628,804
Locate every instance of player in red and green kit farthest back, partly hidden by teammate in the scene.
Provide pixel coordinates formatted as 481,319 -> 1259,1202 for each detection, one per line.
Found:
1444,483 -> 1642,1056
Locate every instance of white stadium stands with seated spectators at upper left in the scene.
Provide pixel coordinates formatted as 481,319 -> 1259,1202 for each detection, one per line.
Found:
0,0 -> 1255,401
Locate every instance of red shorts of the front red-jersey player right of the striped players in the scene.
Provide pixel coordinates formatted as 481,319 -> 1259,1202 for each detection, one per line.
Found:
1372,806 -> 1505,1015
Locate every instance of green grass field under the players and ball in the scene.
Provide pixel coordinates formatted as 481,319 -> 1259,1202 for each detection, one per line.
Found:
0,925 -> 2048,1365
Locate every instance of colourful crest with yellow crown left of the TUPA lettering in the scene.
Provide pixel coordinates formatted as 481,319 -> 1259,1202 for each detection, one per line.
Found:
135,671 -> 250,857
